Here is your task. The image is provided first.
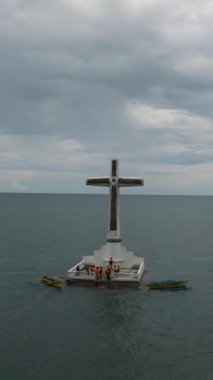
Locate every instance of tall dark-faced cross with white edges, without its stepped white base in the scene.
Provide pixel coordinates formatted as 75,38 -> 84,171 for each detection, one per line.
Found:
86,160 -> 144,242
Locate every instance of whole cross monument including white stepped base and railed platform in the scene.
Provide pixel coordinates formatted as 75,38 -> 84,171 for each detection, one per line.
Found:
68,160 -> 145,284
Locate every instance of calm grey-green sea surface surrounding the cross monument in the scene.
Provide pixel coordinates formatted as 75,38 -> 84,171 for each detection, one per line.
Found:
0,194 -> 213,380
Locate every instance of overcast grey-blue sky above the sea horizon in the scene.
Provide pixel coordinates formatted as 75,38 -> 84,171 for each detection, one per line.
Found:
0,0 -> 213,195
